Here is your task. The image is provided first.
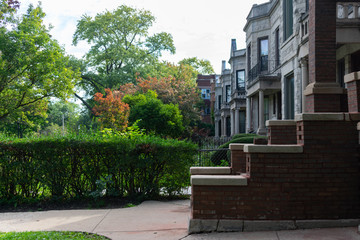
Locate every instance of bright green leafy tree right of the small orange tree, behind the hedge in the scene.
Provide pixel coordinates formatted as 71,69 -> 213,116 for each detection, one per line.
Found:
123,90 -> 184,138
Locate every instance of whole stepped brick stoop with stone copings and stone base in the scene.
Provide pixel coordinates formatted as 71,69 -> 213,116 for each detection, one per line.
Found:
189,113 -> 360,232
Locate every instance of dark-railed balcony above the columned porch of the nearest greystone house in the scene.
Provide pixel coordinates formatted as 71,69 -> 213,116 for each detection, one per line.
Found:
247,60 -> 280,89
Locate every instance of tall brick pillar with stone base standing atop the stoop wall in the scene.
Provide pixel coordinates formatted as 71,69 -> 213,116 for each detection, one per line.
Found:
304,0 -> 344,112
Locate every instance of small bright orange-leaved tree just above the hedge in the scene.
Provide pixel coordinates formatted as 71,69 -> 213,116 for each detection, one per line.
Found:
93,89 -> 130,131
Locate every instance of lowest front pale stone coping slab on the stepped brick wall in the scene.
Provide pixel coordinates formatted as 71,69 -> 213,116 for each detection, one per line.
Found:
190,175 -> 247,186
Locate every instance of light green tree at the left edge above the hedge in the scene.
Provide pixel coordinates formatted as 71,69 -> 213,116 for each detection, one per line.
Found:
0,5 -> 79,122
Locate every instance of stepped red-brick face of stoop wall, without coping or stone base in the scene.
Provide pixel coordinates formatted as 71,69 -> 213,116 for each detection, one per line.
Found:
192,121 -> 360,220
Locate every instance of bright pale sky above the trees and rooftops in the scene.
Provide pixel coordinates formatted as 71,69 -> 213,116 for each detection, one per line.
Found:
20,0 -> 268,74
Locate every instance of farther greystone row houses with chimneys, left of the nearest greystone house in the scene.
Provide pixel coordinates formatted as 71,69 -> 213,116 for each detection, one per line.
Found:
214,39 -> 246,137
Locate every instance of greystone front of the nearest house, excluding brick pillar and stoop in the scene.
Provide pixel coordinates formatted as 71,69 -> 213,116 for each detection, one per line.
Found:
248,0 -> 360,135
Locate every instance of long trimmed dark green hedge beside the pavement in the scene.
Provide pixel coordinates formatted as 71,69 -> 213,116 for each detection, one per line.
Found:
0,136 -> 197,199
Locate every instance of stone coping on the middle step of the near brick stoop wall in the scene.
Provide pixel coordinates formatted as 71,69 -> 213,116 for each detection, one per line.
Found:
244,144 -> 303,153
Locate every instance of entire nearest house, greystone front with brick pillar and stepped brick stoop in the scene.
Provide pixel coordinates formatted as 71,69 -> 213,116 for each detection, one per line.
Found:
189,0 -> 360,233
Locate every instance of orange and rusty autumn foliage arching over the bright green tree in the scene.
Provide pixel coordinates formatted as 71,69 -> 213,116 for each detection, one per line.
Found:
93,77 -> 199,131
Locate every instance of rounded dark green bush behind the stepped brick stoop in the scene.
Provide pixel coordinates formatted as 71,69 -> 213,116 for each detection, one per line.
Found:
210,133 -> 266,165
